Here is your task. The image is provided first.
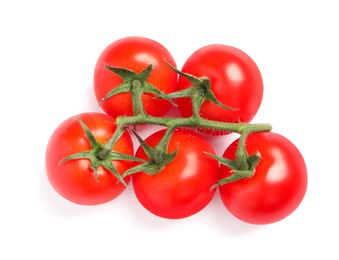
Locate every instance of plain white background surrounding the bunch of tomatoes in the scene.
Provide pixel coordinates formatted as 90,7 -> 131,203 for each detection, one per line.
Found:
0,0 -> 339,260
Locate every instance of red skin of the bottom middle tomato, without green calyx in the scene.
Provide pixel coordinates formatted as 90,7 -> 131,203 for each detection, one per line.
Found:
132,129 -> 219,219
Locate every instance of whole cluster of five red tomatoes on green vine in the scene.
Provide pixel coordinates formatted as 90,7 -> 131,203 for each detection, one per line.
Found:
46,37 -> 307,224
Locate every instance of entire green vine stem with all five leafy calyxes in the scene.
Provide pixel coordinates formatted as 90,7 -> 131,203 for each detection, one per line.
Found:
62,63 -> 272,189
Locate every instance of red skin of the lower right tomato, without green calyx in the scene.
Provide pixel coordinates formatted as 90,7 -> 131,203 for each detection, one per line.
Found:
219,132 -> 307,224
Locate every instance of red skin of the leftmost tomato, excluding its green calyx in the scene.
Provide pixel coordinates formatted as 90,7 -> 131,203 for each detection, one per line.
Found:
45,113 -> 134,205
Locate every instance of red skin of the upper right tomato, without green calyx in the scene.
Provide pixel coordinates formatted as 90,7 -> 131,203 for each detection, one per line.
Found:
177,44 -> 263,134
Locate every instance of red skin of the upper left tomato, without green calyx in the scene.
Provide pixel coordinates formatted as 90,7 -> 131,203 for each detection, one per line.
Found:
94,36 -> 178,118
